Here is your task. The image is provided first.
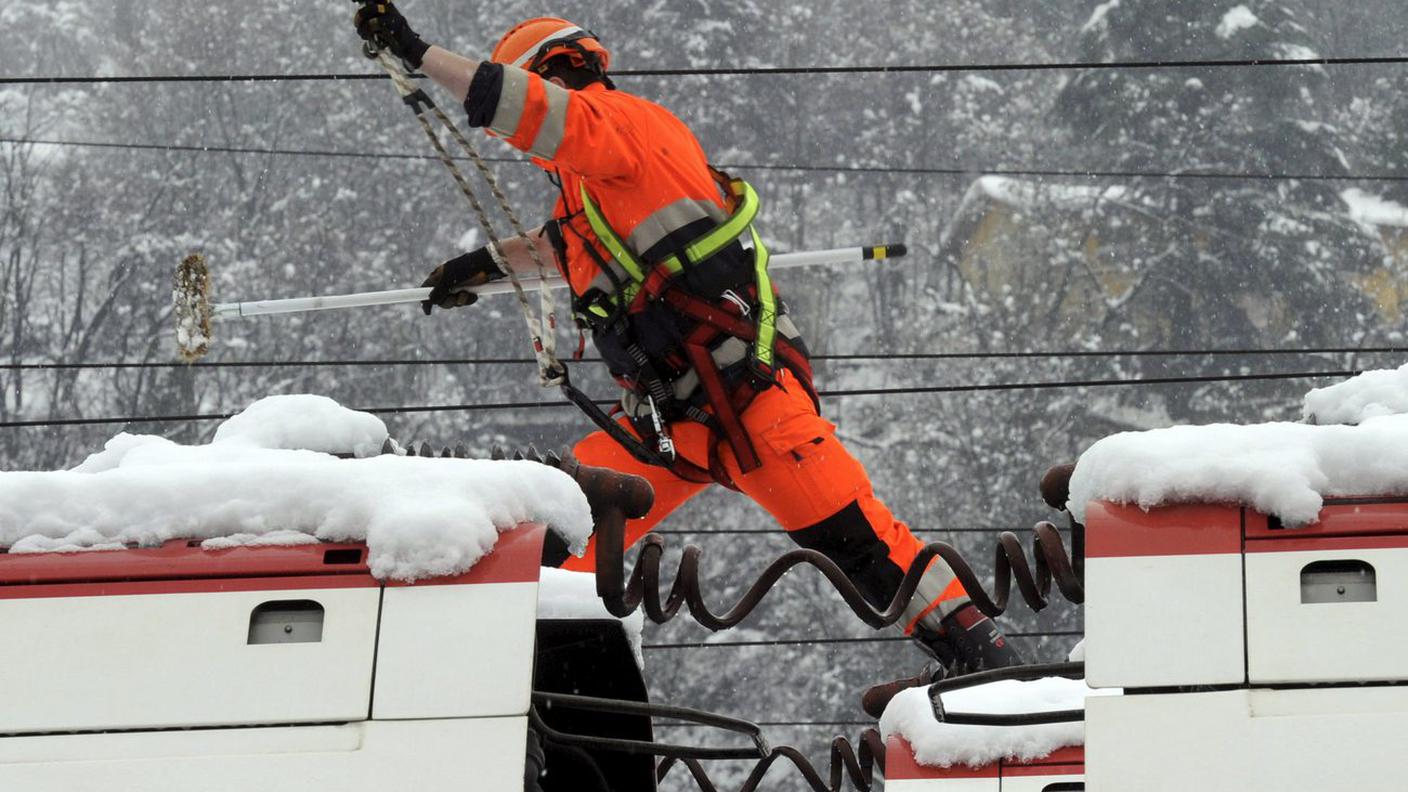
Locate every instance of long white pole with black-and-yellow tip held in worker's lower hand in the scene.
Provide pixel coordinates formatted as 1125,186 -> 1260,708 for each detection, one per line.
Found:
211,245 -> 908,318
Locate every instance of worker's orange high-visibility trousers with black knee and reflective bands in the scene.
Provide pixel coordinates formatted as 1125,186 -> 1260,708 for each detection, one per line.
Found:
563,369 -> 969,633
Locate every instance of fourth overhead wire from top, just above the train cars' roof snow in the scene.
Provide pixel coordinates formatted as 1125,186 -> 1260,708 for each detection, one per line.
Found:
0,371 -> 1363,428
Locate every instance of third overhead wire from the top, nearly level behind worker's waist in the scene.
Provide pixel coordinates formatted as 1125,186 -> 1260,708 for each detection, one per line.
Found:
0,347 -> 1408,371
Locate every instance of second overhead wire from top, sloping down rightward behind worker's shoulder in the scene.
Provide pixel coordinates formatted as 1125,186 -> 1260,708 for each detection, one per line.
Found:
0,138 -> 1408,182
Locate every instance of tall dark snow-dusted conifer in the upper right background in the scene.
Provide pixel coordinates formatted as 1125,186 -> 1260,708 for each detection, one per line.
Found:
1059,0 -> 1380,347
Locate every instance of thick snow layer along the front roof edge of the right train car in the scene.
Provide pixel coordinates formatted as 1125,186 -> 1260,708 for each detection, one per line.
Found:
1067,416 -> 1408,527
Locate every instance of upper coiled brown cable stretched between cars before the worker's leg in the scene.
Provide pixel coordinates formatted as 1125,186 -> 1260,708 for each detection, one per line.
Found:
597,514 -> 1086,631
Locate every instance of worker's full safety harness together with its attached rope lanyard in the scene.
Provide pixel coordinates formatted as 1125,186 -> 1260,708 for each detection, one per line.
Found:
359,18 -> 817,486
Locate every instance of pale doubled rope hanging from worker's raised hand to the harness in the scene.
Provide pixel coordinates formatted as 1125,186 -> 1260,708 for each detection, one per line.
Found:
365,45 -> 567,388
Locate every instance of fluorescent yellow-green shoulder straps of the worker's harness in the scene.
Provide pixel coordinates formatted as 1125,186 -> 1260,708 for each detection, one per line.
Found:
582,179 -> 777,369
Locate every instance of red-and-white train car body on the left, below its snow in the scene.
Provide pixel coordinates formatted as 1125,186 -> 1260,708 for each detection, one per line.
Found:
0,526 -> 543,792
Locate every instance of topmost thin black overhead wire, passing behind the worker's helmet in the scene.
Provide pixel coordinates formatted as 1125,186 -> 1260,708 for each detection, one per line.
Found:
0,55 -> 1408,85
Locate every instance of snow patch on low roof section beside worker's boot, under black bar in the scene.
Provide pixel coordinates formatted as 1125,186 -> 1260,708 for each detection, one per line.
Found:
880,676 -> 1121,768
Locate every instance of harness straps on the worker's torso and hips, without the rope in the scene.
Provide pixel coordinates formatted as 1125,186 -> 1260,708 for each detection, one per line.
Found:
576,171 -> 815,486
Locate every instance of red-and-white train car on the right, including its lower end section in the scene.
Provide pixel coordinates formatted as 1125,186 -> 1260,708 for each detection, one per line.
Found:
886,497 -> 1408,792
